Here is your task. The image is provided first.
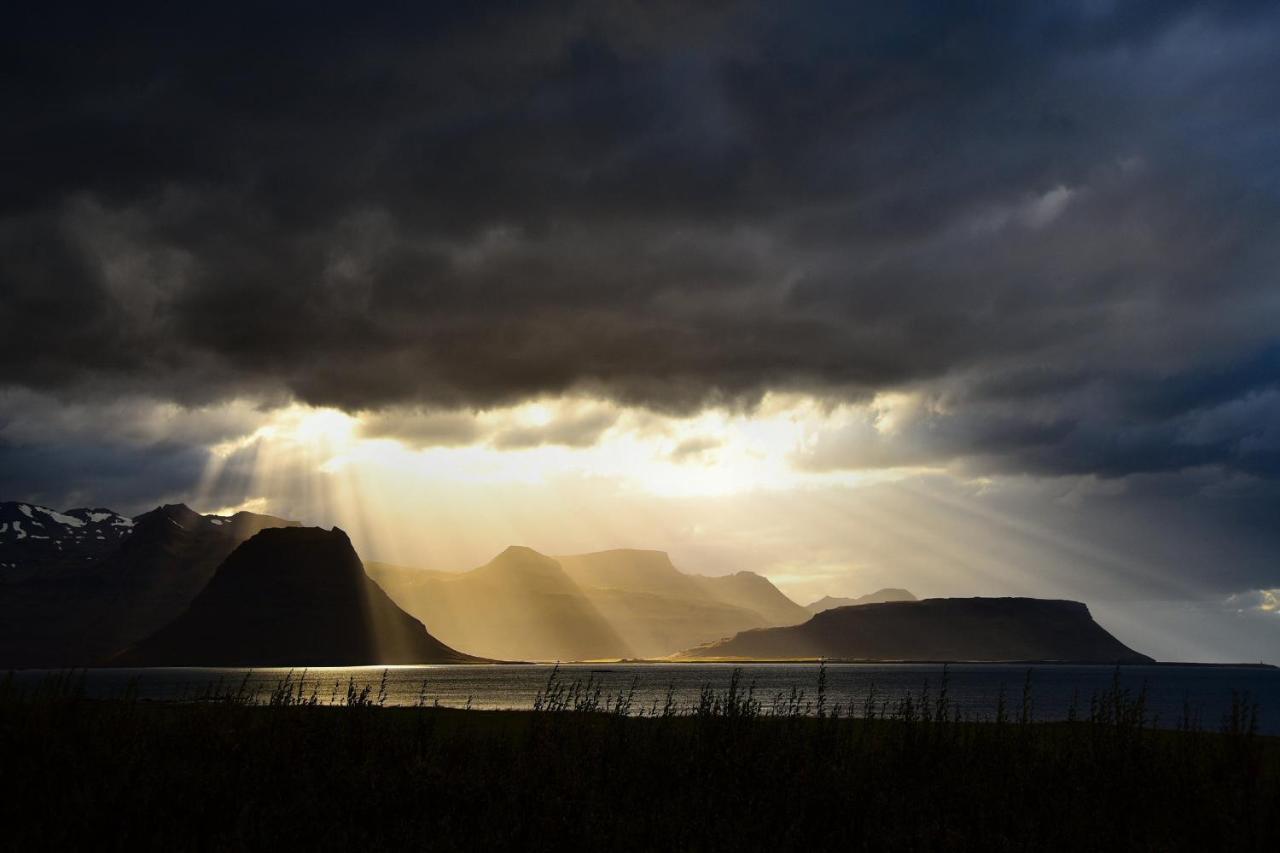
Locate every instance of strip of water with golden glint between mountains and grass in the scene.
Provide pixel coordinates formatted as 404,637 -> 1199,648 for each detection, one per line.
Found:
14,663 -> 1280,734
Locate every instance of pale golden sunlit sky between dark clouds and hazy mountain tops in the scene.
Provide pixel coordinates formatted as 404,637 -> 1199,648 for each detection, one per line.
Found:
180,396 -> 1239,660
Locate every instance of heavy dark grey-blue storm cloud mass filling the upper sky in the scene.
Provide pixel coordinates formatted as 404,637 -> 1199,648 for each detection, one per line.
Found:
0,3 -> 1280,476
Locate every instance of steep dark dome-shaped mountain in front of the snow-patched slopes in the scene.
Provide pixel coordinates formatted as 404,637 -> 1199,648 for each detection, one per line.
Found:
113,528 -> 479,666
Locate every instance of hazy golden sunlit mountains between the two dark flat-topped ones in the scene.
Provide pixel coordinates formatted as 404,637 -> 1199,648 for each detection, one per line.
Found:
369,547 -> 808,661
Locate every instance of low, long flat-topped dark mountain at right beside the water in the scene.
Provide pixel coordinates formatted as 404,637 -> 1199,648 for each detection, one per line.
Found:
680,598 -> 1151,663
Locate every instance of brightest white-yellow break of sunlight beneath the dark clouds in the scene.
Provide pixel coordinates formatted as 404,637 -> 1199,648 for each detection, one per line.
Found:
199,398 -> 911,497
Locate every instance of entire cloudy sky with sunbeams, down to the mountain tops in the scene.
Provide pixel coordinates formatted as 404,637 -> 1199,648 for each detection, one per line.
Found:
0,0 -> 1280,662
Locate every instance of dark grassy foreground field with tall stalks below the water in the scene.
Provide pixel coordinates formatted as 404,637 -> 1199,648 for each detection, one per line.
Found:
0,678 -> 1280,850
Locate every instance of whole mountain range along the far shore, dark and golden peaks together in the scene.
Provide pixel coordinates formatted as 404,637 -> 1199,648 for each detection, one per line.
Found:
0,502 -> 1131,667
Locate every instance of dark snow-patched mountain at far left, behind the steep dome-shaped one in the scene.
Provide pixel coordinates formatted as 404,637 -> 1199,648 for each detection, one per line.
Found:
0,503 -> 297,667
